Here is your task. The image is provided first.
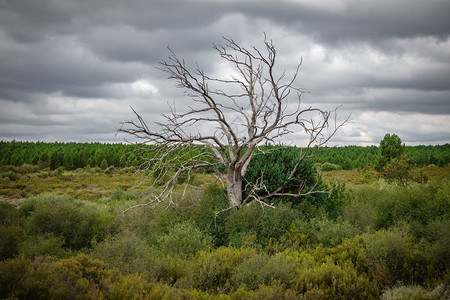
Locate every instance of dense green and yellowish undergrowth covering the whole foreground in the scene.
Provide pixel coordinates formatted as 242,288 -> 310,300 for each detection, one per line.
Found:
0,165 -> 450,299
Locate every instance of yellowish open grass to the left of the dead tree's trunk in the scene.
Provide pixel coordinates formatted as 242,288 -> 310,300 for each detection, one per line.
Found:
0,166 -> 218,204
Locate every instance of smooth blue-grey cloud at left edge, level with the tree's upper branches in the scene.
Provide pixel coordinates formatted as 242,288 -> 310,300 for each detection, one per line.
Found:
0,34 -> 153,100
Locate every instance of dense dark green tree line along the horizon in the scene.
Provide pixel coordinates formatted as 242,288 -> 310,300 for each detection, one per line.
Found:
0,141 -> 450,170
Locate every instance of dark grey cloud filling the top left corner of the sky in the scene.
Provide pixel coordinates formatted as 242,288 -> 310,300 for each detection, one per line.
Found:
0,0 -> 226,43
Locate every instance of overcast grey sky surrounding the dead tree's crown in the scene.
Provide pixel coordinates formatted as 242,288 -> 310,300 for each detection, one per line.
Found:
0,0 -> 450,145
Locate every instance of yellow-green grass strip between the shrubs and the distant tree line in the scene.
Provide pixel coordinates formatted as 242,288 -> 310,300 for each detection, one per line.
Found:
0,165 -> 450,202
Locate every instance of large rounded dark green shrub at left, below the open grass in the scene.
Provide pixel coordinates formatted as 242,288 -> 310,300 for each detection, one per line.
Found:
20,194 -> 114,249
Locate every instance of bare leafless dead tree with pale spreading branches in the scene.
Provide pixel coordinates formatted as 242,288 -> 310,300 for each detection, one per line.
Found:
118,38 -> 347,210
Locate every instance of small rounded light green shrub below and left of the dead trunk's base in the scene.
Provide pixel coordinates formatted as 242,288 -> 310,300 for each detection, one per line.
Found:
158,222 -> 211,257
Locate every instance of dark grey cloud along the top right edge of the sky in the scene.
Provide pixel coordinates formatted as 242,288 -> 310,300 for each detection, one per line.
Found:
239,0 -> 450,43
